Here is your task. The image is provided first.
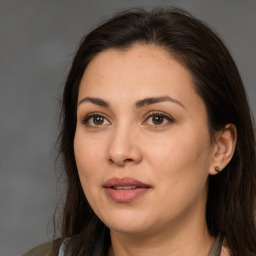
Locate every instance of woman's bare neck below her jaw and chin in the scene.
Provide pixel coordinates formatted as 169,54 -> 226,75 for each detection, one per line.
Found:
109,191 -> 214,256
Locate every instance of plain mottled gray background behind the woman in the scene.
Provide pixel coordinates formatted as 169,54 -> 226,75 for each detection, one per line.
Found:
0,0 -> 256,256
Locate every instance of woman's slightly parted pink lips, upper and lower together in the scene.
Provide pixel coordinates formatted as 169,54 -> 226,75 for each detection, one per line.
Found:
103,177 -> 151,203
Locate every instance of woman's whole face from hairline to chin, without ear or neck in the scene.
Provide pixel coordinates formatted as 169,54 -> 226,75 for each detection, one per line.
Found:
74,45 -> 216,234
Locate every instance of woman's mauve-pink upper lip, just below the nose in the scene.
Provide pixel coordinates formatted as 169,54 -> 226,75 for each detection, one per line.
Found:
103,177 -> 150,188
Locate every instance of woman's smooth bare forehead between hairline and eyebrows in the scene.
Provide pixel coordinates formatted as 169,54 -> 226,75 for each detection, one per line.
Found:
79,45 -> 198,108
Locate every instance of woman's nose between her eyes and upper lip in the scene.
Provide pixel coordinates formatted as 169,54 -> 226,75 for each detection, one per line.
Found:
108,125 -> 142,166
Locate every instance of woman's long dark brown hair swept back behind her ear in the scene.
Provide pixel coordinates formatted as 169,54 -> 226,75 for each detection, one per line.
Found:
55,7 -> 256,256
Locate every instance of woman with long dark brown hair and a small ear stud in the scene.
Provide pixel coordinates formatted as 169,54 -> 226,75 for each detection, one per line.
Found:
22,5 -> 256,256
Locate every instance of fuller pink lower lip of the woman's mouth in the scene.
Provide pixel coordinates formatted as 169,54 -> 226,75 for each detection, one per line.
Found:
105,188 -> 149,203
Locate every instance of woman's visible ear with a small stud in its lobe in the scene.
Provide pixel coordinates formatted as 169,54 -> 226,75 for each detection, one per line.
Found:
209,124 -> 237,175
